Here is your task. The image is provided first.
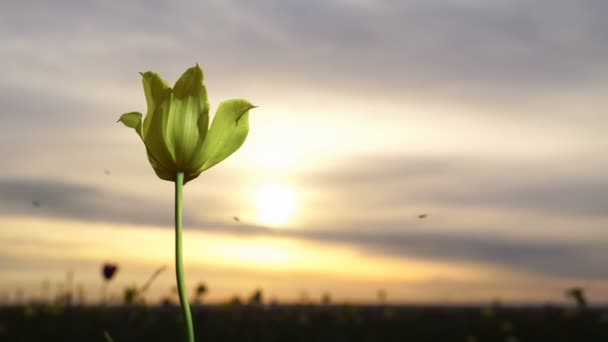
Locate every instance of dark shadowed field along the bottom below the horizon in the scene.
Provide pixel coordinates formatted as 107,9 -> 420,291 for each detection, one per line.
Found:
0,305 -> 608,342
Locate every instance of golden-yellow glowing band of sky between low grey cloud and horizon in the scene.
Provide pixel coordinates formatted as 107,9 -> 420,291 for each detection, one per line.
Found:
0,218 -> 608,302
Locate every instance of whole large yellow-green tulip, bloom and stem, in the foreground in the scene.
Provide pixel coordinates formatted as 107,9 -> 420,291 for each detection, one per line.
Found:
118,64 -> 255,342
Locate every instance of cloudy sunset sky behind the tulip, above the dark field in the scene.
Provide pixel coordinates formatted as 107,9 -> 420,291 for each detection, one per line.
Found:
0,0 -> 608,303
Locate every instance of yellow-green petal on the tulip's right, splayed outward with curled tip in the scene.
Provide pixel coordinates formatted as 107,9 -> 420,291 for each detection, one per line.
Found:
197,99 -> 256,173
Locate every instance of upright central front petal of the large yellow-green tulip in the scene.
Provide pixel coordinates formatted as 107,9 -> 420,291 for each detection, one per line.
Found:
167,64 -> 209,171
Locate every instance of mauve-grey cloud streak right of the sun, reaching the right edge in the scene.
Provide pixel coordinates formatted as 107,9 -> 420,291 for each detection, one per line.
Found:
300,156 -> 608,218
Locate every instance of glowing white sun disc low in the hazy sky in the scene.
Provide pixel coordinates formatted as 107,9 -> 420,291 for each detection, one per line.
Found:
255,184 -> 297,226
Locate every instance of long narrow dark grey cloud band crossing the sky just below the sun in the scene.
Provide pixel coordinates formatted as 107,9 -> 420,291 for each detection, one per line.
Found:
0,174 -> 608,279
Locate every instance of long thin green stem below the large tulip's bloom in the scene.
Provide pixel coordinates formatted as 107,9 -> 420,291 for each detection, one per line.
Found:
175,172 -> 194,342
